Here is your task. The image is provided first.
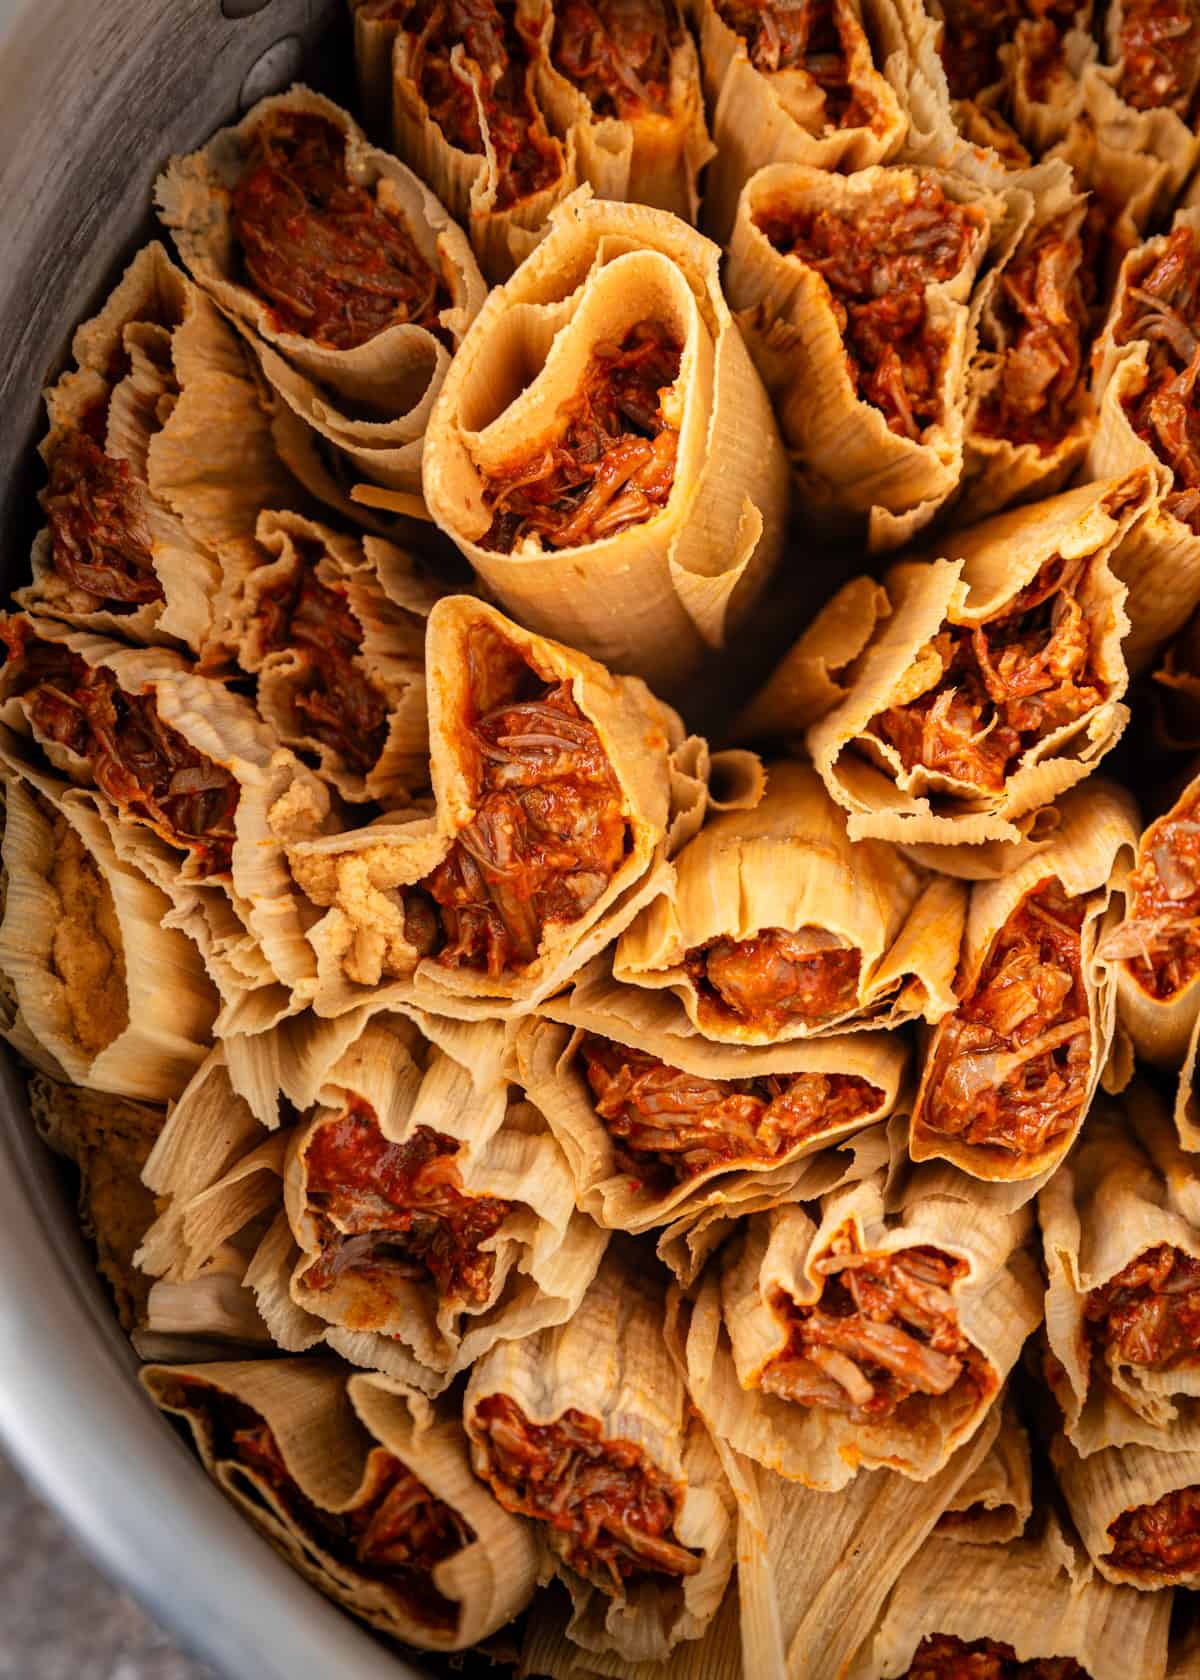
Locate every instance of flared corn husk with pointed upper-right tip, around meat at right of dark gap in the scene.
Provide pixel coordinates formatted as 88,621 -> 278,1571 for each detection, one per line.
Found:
807,470 -> 1153,853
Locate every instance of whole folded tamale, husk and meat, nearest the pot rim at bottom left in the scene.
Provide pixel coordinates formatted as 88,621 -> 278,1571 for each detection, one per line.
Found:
141,1359 -> 536,1651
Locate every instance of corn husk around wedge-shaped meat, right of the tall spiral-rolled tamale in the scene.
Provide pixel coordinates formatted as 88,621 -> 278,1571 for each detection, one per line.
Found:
726,163 -> 1005,548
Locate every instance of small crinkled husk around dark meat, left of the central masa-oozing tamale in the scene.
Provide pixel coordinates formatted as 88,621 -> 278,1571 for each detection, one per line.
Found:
220,512 -> 440,805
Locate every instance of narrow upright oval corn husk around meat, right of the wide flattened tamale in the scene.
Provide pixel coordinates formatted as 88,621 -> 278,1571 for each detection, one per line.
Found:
909,780 -> 1136,1201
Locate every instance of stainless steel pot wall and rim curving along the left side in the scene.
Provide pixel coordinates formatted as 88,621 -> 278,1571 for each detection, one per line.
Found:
0,0 -> 430,1680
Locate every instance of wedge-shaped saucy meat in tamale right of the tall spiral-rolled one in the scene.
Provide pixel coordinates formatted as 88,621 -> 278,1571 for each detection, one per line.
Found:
755,178 -> 987,442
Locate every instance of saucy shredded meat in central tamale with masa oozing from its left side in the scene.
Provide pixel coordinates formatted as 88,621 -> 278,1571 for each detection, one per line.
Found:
416,627 -> 630,976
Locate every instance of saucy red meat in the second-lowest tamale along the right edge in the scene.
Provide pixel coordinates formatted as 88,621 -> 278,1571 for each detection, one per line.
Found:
1084,1243 -> 1200,1371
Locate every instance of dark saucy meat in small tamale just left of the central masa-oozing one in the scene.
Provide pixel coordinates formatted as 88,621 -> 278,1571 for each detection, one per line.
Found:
259,564 -> 388,774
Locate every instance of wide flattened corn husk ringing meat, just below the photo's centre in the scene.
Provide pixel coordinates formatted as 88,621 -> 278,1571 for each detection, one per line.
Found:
513,956 -> 906,1231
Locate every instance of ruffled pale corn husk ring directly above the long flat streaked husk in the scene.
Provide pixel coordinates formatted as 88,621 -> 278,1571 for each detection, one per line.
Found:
686,1174 -> 1042,1492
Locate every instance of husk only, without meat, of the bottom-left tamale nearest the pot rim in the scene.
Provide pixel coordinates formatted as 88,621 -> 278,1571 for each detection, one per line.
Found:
141,1359 -> 536,1651
